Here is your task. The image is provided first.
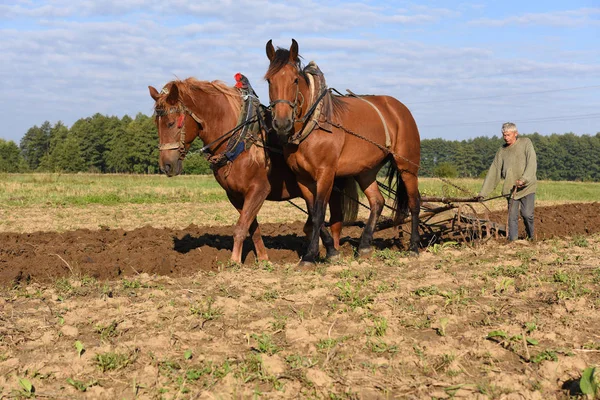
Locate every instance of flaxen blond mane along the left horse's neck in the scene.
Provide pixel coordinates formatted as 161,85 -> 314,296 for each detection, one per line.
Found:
155,77 -> 242,112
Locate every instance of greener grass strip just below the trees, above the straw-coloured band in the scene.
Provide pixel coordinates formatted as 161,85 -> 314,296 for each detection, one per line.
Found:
0,173 -> 600,207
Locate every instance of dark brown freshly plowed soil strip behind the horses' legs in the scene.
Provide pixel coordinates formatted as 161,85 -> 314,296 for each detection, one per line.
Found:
0,202 -> 600,285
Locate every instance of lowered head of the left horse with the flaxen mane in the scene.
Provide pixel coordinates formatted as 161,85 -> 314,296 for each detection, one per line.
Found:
148,81 -> 201,176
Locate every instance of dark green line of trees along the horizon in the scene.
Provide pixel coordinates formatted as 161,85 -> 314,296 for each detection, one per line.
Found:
0,113 -> 600,182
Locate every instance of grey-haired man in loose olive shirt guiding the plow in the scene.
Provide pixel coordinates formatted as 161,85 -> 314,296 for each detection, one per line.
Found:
478,122 -> 537,240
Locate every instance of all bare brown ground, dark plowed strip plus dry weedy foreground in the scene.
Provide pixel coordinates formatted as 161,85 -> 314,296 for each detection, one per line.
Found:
0,203 -> 600,399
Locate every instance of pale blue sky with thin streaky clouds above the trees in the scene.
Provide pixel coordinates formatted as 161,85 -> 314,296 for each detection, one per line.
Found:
0,0 -> 600,143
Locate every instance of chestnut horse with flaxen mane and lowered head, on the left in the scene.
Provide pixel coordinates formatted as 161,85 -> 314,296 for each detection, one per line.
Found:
148,74 -> 357,263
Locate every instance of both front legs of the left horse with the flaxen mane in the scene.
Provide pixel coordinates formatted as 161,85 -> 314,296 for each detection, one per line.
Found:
227,188 -> 269,264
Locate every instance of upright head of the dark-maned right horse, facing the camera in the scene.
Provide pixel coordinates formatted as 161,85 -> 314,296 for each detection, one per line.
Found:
265,39 -> 305,143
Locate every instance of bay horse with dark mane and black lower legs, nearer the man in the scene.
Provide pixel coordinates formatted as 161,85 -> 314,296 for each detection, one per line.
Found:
265,39 -> 421,263
